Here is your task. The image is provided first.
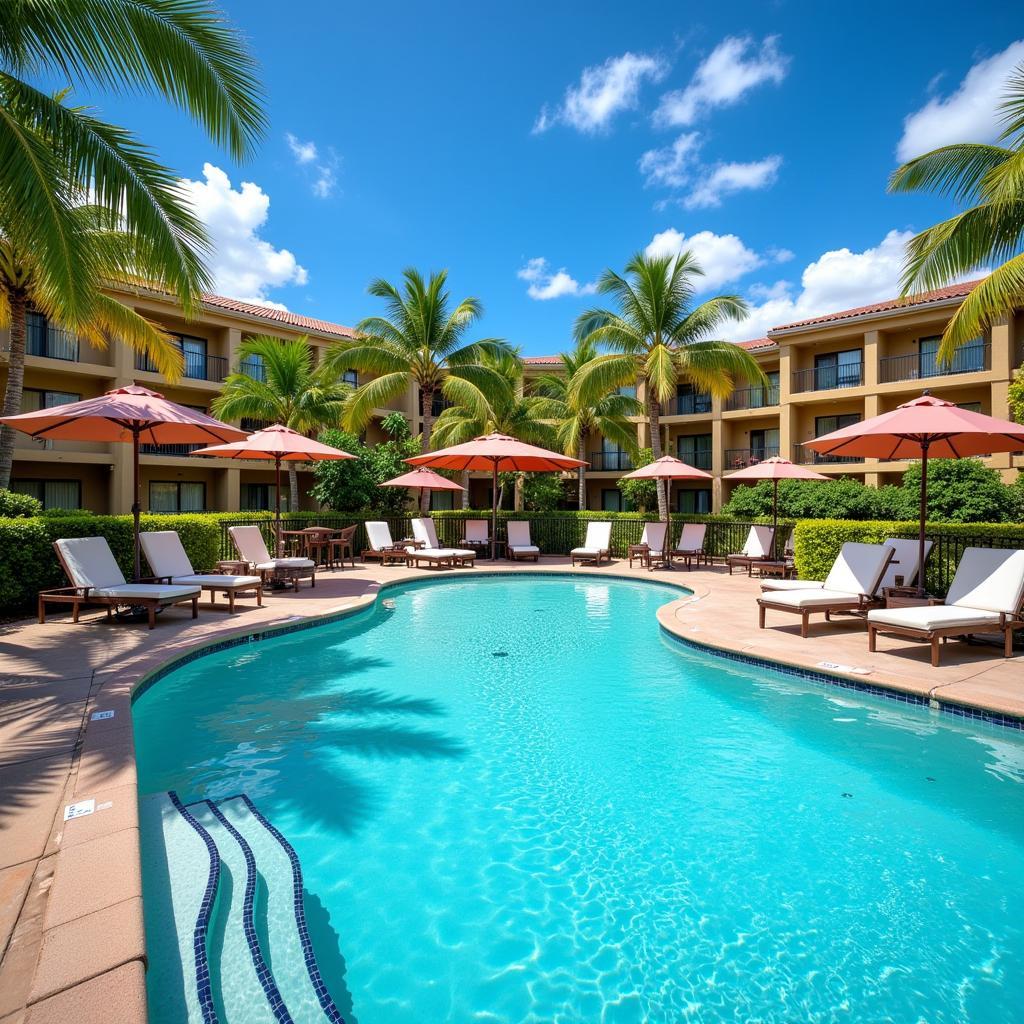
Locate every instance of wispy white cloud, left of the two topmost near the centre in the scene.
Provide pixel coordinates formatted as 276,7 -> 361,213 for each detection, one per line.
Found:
534,53 -> 668,134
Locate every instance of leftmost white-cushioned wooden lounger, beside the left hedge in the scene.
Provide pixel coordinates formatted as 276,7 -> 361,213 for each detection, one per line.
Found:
39,537 -> 202,630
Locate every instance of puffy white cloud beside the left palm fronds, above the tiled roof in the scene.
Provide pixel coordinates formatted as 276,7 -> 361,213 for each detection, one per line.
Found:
181,164 -> 307,309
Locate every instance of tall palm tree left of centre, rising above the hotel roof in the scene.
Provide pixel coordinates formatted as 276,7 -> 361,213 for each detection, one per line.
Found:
326,268 -> 509,512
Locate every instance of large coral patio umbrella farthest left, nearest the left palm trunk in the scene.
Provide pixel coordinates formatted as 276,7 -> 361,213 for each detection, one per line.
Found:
0,384 -> 246,580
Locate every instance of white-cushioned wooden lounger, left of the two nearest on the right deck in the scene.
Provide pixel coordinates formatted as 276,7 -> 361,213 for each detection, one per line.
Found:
758,542 -> 893,639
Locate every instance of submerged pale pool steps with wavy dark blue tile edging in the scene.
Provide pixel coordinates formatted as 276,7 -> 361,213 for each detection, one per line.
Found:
167,791 -> 344,1024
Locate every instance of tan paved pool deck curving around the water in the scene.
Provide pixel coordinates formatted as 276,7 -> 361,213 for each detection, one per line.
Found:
0,558 -> 1024,1024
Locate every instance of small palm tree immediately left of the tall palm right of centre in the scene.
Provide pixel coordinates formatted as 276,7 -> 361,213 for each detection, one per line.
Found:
535,338 -> 643,511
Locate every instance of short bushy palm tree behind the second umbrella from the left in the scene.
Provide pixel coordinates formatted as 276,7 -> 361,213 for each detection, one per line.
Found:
211,335 -> 351,510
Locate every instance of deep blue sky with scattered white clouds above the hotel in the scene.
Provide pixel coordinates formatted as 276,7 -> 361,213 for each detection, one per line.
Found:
86,0 -> 1024,354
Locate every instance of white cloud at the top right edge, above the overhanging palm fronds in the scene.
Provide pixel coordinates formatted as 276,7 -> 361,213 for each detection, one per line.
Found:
896,40 -> 1024,161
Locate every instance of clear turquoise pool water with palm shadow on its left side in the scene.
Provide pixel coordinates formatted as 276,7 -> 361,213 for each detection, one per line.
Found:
134,577 -> 1024,1024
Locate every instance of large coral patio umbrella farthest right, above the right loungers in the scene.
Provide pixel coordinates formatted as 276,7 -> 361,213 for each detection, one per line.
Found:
804,391 -> 1024,595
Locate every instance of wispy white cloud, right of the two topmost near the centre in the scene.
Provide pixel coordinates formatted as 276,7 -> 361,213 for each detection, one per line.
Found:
654,36 -> 790,125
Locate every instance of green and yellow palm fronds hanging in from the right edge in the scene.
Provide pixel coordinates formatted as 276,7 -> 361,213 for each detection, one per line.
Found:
889,65 -> 1024,361
